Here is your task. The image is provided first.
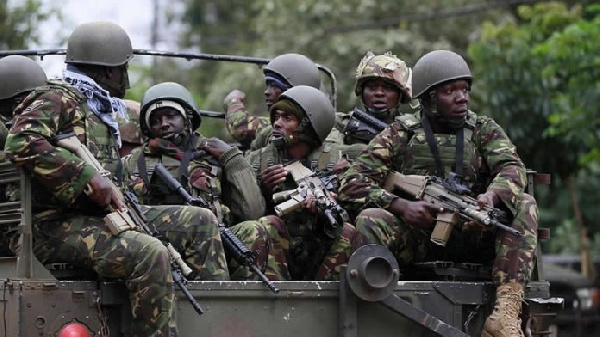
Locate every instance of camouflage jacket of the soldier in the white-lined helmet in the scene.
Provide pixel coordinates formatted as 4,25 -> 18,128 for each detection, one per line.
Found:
124,133 -> 265,225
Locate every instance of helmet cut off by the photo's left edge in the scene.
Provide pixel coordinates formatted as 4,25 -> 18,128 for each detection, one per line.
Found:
0,55 -> 46,99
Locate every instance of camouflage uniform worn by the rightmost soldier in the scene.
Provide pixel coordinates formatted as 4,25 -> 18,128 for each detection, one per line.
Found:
339,112 -> 537,283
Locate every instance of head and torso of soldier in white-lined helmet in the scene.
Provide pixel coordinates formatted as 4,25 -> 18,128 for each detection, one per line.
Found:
125,82 -> 265,230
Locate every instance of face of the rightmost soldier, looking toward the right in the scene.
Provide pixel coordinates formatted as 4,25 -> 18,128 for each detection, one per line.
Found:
435,80 -> 470,119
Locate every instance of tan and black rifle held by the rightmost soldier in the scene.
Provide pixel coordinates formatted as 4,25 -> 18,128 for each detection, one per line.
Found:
384,172 -> 522,246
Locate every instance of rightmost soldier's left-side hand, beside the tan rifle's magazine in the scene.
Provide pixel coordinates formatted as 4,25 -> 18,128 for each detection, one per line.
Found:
388,198 -> 444,228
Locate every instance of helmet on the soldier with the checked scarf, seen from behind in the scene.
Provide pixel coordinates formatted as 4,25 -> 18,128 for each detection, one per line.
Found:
65,21 -> 133,67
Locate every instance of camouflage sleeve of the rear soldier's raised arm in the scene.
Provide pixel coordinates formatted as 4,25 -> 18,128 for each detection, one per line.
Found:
225,101 -> 271,148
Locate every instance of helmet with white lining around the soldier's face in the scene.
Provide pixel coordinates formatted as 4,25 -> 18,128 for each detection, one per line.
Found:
140,82 -> 202,134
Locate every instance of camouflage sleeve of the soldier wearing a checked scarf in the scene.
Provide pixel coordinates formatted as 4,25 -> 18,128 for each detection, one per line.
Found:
5,90 -> 96,206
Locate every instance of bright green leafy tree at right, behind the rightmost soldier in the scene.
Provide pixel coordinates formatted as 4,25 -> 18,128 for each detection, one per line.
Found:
469,2 -> 600,255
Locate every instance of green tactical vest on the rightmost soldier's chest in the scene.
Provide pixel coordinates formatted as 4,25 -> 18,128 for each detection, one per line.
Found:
394,111 -> 488,193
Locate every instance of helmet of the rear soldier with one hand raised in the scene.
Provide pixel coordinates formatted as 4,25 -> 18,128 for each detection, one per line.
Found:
263,53 -> 321,89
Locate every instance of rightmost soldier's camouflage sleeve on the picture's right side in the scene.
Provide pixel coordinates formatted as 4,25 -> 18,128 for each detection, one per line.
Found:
473,118 -> 527,214
